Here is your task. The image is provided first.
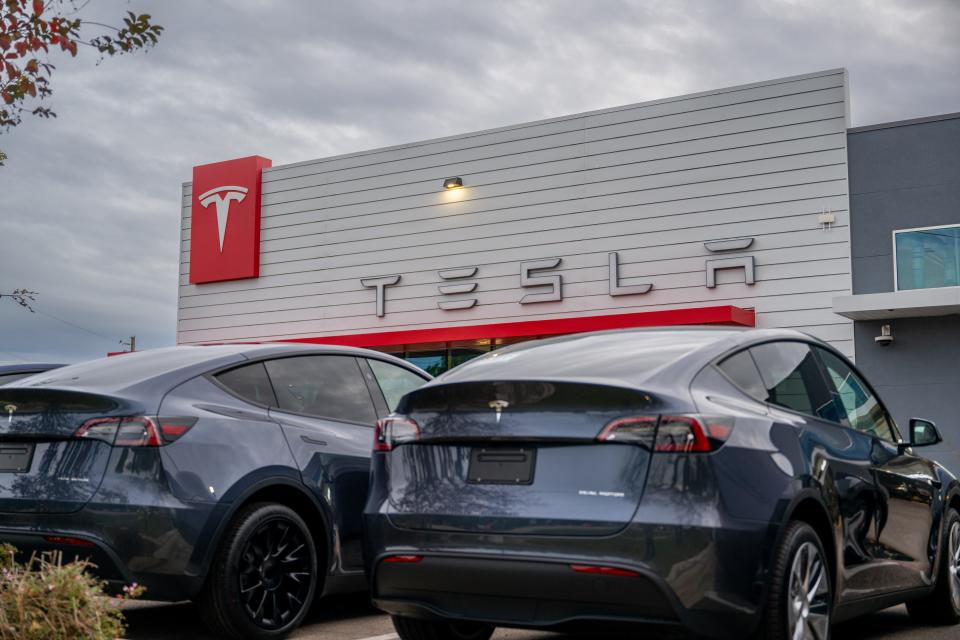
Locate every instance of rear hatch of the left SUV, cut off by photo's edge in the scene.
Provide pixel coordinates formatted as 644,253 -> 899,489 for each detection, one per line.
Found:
0,387 -> 140,513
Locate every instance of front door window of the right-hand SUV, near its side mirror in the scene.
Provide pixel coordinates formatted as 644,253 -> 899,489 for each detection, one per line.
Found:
817,348 -> 897,442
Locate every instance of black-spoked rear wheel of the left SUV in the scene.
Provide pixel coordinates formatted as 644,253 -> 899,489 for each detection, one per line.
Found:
197,502 -> 318,640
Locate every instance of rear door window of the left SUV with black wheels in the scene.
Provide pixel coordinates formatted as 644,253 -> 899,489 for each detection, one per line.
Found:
266,356 -> 377,425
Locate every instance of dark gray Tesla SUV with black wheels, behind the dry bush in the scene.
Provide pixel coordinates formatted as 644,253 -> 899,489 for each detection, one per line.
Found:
0,345 -> 429,638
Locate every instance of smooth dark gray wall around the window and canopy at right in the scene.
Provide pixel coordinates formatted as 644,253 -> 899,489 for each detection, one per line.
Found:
848,114 -> 960,472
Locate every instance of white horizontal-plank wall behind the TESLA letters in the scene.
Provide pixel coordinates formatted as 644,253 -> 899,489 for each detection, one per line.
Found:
178,70 -> 853,354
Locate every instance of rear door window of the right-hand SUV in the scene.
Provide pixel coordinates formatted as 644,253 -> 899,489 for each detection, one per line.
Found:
750,342 -> 836,420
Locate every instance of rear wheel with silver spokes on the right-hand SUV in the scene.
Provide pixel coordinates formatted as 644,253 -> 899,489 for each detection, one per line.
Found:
757,521 -> 833,640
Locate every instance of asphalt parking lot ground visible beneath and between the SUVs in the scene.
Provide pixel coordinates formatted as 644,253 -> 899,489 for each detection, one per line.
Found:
126,597 -> 960,640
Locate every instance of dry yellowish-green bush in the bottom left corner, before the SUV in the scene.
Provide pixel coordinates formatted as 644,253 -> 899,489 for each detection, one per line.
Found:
0,545 -> 143,640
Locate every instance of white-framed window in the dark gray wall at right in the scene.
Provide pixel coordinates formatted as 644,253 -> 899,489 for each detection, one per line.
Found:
893,225 -> 960,291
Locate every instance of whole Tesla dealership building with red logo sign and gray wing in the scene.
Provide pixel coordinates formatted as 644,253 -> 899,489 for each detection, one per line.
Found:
177,70 -> 960,469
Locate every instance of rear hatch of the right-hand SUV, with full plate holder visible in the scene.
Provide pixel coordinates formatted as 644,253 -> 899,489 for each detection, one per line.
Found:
378,381 -> 677,536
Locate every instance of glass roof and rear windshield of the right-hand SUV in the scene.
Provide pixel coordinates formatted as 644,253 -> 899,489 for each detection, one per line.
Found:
436,327 -> 819,390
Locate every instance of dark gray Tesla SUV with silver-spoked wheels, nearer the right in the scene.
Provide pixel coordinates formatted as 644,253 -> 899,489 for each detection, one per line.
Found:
364,329 -> 960,640
